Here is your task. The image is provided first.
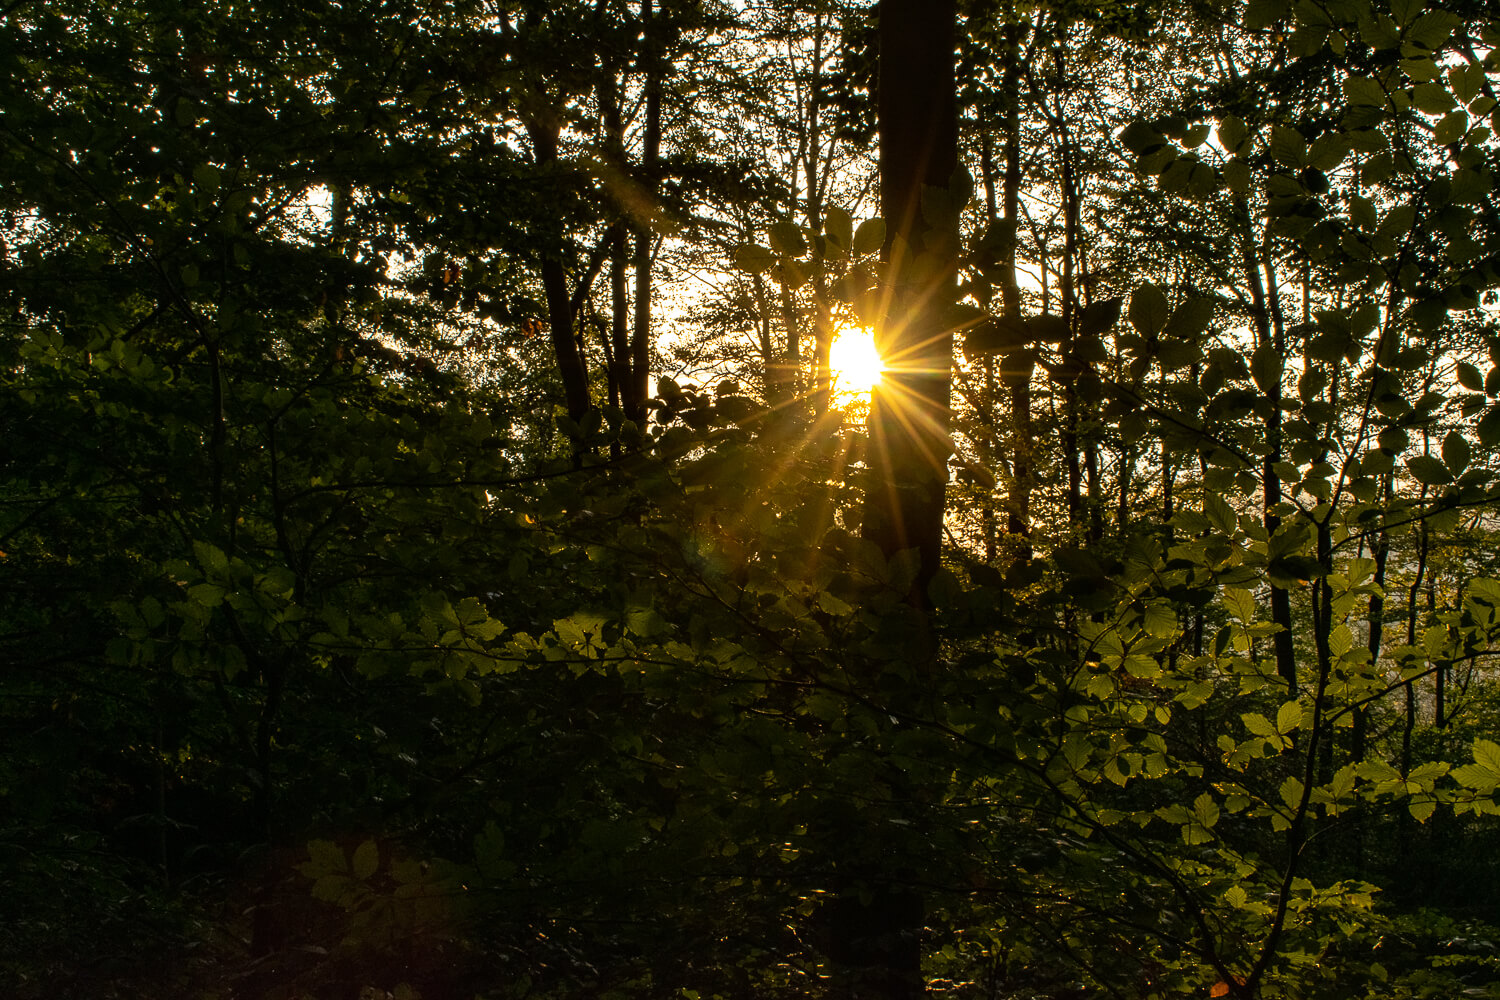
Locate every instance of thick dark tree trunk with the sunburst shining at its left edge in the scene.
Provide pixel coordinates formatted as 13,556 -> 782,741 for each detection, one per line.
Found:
824,0 -> 959,1000
